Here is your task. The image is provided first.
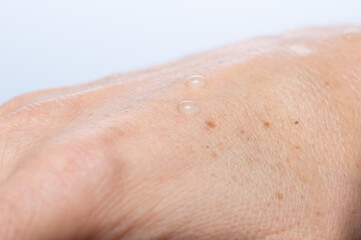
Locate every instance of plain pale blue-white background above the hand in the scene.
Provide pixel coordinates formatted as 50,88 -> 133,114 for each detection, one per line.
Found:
0,0 -> 361,103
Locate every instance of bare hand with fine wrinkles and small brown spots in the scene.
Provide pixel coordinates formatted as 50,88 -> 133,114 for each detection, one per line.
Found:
0,26 -> 361,240
